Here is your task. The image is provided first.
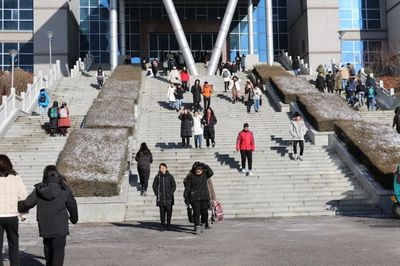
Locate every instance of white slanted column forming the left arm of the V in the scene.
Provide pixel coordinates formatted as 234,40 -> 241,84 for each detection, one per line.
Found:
163,0 -> 198,76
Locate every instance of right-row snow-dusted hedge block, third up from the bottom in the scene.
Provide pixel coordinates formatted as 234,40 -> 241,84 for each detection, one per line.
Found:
270,76 -> 317,104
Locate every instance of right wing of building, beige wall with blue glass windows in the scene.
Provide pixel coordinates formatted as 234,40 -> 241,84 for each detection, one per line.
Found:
288,0 -> 400,73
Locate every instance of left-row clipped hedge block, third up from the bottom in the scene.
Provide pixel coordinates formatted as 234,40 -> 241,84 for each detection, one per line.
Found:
98,78 -> 139,101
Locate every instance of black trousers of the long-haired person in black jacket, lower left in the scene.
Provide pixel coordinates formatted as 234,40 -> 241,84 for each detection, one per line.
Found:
43,236 -> 66,266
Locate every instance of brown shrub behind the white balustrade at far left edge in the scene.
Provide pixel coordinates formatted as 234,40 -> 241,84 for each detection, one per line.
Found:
0,68 -> 33,104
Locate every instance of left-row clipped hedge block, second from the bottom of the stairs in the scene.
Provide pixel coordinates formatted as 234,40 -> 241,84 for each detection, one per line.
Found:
85,98 -> 135,129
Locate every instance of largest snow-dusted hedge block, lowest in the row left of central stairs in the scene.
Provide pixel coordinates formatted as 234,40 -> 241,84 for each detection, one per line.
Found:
57,128 -> 129,197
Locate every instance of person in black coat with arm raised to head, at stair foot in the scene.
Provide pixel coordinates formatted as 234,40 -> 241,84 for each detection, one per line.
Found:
183,163 -> 214,234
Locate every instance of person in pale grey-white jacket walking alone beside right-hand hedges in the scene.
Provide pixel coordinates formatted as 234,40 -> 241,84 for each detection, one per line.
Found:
289,112 -> 307,161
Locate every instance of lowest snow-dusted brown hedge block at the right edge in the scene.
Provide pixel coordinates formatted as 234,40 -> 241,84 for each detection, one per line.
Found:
335,121 -> 400,189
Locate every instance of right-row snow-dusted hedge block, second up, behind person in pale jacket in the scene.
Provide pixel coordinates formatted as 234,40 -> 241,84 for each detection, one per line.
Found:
297,92 -> 362,131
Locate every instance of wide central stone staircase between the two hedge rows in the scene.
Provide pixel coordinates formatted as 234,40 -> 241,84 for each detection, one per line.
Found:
125,69 -> 379,221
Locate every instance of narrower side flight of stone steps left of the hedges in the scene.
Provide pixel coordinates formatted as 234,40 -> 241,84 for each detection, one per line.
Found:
0,72 -> 98,216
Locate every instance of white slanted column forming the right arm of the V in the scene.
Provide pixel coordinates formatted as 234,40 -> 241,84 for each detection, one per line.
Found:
207,0 -> 238,75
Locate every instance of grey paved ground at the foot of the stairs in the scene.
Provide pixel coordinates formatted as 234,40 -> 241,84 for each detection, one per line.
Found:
6,217 -> 400,266
